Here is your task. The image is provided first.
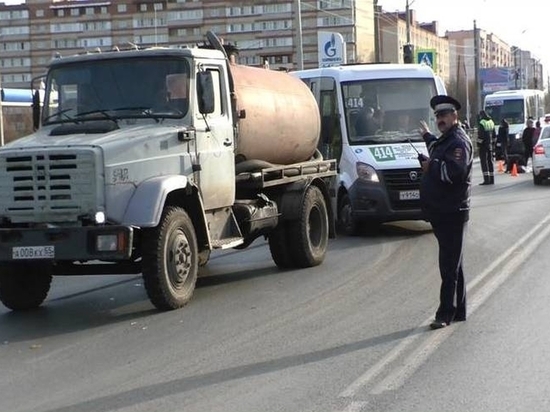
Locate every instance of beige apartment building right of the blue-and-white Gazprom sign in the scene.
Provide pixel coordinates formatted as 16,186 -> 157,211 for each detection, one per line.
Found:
378,9 -> 450,83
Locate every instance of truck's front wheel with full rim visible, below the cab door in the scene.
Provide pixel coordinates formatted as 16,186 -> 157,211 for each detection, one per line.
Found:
142,206 -> 199,310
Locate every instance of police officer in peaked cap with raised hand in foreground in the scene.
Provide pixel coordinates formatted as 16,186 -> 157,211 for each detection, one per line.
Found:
419,96 -> 473,329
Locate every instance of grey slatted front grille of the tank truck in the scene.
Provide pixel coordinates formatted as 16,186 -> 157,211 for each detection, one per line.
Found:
0,149 -> 101,223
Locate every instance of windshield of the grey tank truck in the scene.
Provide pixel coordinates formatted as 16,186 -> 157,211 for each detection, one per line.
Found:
42,55 -> 189,125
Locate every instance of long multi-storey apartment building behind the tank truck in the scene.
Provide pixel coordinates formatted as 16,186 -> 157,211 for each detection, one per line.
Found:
0,0 -> 384,87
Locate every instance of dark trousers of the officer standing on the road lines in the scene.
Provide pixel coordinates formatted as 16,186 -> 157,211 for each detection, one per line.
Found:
431,216 -> 467,323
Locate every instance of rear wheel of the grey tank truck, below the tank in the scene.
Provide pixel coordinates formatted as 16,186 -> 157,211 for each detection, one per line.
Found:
287,186 -> 329,268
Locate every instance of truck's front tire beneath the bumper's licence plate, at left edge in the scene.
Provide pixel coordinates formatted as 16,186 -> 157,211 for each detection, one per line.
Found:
0,264 -> 52,310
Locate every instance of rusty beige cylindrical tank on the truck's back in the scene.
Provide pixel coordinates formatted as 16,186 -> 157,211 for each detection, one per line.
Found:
230,64 -> 321,164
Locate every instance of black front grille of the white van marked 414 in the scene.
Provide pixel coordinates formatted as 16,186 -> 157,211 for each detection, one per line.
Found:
382,168 -> 422,210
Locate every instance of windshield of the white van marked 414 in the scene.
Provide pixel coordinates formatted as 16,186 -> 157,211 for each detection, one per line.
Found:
342,78 -> 437,145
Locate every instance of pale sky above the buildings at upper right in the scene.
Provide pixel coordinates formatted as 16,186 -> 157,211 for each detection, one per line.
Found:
380,0 -> 550,69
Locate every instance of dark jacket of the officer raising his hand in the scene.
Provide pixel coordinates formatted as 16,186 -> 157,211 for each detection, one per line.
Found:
420,125 -> 473,221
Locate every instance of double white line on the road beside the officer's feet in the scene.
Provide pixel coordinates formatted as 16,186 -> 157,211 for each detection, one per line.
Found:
338,215 -> 550,402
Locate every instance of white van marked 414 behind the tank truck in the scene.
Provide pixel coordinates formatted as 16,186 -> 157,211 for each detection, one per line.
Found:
292,64 -> 446,235
